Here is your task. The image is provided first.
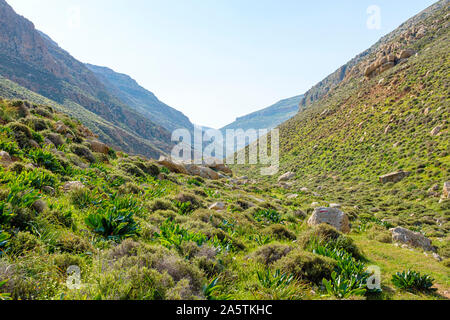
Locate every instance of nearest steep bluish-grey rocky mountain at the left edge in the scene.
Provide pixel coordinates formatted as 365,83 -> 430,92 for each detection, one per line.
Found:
0,0 -> 172,156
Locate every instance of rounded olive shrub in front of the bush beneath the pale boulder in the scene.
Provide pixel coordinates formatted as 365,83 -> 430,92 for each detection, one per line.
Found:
274,249 -> 337,284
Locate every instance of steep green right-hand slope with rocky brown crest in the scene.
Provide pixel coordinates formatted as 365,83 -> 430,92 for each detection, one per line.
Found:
234,0 -> 450,245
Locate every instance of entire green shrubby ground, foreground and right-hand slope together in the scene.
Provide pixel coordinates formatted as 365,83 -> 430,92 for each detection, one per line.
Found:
0,0 -> 450,300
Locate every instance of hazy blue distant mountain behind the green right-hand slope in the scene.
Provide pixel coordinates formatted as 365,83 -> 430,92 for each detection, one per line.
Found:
220,96 -> 303,132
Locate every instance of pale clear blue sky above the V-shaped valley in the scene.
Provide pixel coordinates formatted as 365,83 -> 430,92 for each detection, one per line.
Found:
7,0 -> 435,128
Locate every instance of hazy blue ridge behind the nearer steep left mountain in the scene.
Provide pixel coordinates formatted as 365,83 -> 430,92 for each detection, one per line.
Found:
86,64 -> 194,131
